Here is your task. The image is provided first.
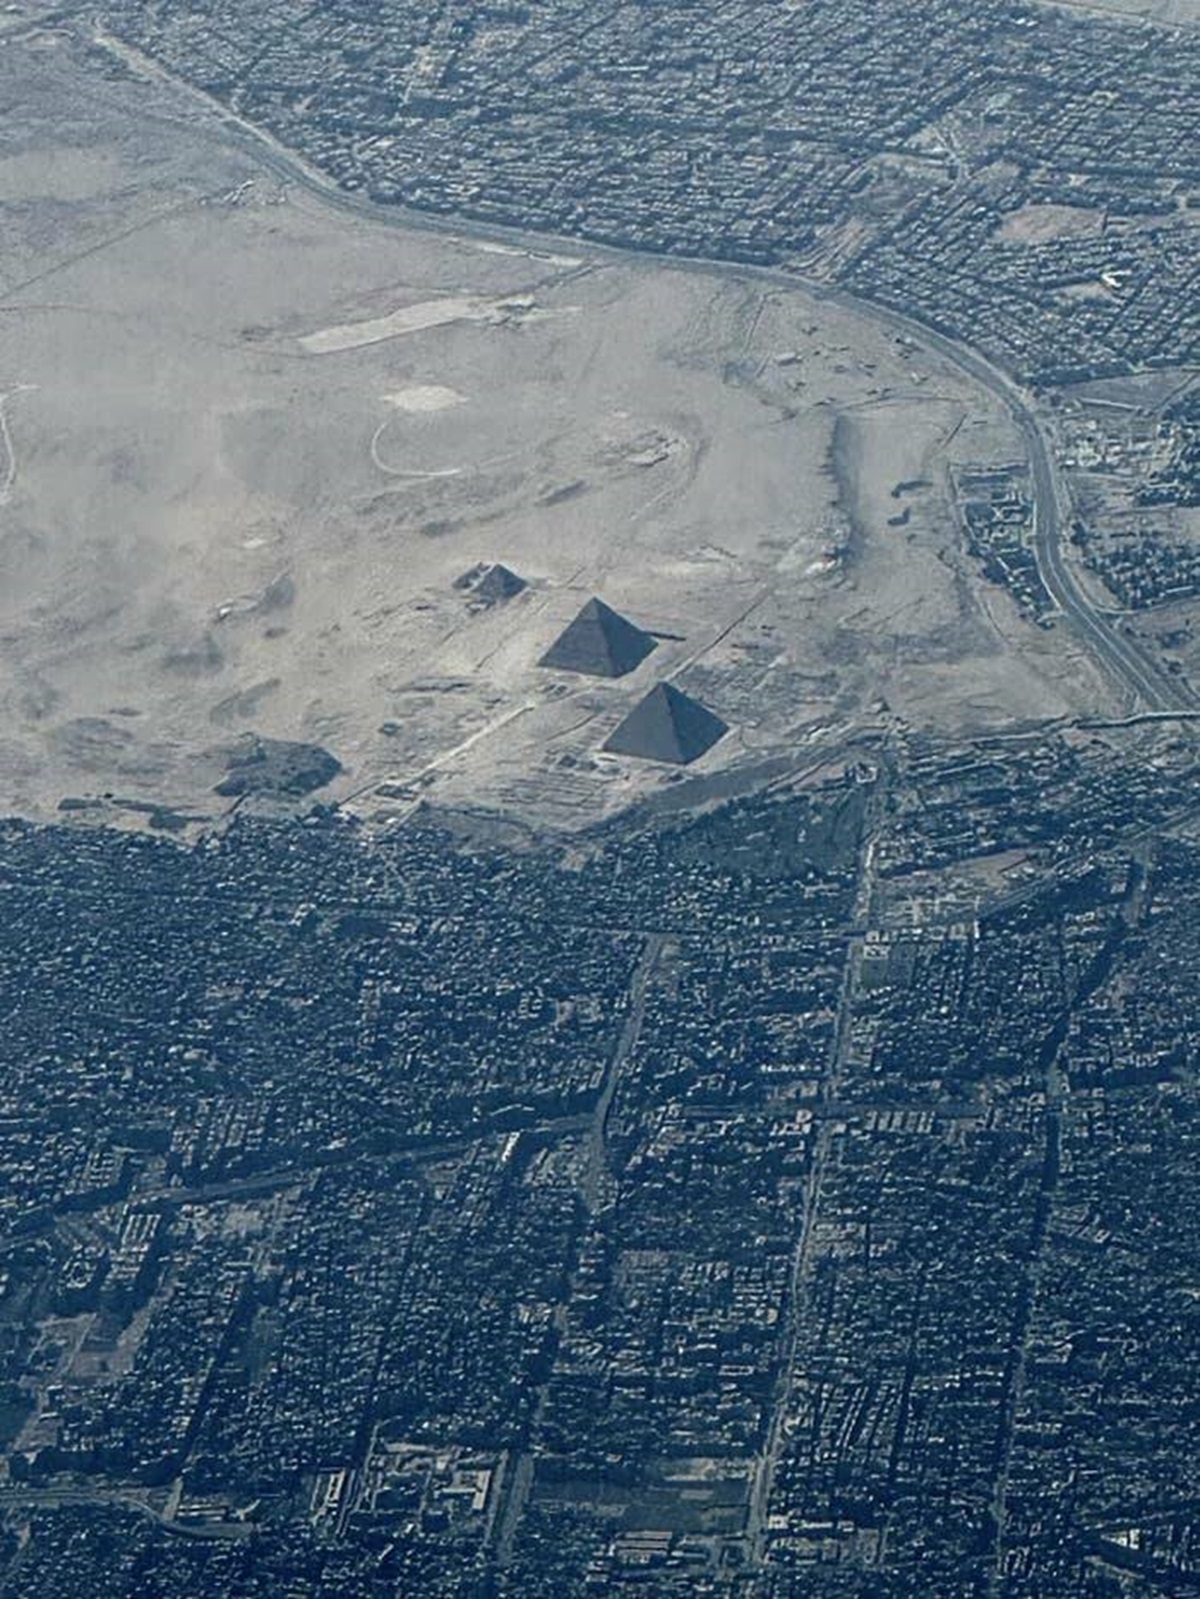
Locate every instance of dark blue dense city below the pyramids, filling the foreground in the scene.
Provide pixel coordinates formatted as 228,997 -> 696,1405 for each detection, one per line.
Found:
0,732 -> 1200,1599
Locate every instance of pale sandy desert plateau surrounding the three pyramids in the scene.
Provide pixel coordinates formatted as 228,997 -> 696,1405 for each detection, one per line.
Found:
0,28 -> 1102,825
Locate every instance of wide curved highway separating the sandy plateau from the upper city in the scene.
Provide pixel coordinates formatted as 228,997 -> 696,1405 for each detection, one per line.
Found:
93,24 -> 1200,713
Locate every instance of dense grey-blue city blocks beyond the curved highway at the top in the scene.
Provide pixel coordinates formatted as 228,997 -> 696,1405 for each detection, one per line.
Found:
102,0 -> 1200,382
